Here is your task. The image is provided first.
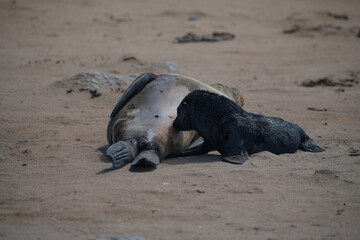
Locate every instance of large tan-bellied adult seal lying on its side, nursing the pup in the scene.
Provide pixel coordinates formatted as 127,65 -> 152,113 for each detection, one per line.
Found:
106,73 -> 243,168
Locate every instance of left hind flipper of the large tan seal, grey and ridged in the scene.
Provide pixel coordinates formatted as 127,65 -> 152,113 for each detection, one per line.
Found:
106,141 -> 137,168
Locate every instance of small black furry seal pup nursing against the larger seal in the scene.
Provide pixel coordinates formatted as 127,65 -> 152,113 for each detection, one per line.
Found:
173,90 -> 325,164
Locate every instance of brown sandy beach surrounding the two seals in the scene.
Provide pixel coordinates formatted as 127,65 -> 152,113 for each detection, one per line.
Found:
0,0 -> 360,240
